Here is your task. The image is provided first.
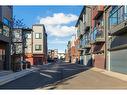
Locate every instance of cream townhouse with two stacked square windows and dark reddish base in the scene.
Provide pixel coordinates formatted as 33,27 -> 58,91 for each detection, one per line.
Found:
32,24 -> 47,65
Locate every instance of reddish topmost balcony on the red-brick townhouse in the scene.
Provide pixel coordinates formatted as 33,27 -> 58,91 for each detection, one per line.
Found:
93,6 -> 104,20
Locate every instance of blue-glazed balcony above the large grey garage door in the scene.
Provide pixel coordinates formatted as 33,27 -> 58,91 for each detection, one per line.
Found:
109,6 -> 127,36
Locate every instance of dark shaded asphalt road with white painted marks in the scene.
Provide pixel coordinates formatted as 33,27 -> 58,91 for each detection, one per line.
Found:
0,63 -> 87,89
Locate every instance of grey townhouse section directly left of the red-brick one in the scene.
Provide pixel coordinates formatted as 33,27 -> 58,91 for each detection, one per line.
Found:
75,6 -> 92,66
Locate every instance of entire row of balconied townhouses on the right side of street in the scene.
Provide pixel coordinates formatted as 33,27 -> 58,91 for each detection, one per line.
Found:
66,6 -> 127,74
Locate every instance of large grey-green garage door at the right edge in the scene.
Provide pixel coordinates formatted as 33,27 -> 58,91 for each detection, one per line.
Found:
110,49 -> 127,74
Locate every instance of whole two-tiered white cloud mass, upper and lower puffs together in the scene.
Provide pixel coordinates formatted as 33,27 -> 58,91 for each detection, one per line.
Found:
39,13 -> 78,37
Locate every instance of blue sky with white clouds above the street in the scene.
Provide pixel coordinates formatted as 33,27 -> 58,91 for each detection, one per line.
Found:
13,5 -> 83,52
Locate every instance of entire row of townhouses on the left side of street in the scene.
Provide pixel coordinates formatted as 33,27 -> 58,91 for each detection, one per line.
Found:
0,6 -> 47,70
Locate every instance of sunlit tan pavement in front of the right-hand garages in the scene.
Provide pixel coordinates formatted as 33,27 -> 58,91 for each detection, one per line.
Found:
43,68 -> 127,90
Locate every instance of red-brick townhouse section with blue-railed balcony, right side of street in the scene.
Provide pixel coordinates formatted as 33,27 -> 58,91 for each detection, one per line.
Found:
91,6 -> 106,69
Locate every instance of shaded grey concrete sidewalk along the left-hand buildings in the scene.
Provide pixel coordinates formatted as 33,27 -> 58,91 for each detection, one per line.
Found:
0,67 -> 38,85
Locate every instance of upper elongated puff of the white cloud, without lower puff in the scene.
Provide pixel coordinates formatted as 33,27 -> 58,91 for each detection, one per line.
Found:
40,13 -> 78,25
